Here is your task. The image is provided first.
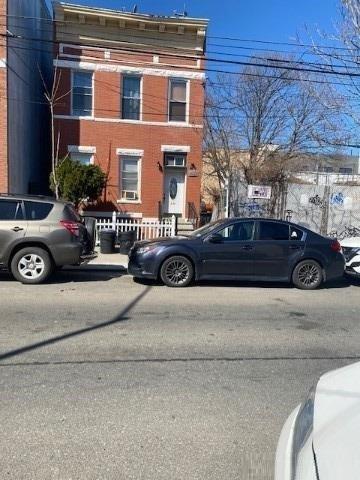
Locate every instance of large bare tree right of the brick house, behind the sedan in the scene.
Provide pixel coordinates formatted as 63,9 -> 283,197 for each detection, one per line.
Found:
205,56 -> 341,218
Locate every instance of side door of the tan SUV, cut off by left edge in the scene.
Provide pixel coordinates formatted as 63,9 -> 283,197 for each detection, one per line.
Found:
0,198 -> 27,263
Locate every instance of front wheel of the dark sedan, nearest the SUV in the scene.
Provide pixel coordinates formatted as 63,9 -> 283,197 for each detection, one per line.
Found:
160,256 -> 194,288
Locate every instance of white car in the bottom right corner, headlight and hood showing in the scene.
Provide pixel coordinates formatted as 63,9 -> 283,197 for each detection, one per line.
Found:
275,362 -> 360,480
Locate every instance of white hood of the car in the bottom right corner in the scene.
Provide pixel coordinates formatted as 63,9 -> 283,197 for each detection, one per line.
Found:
313,362 -> 360,480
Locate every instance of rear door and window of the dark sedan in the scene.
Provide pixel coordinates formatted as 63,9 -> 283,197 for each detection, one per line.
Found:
254,220 -> 305,280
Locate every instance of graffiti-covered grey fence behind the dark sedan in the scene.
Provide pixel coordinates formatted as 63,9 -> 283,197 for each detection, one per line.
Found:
229,184 -> 360,238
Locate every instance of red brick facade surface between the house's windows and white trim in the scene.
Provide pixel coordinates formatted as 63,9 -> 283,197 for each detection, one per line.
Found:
56,69 -> 204,217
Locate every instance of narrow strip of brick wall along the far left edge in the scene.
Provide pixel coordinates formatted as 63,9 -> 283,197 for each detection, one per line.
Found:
0,0 -> 8,192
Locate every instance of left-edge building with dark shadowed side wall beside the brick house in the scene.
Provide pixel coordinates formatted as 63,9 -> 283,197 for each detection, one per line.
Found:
0,0 -> 53,193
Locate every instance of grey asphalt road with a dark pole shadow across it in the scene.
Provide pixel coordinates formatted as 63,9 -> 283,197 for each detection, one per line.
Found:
0,271 -> 360,480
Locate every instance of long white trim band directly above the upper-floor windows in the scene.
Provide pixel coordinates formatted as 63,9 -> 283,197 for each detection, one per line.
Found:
54,59 -> 205,80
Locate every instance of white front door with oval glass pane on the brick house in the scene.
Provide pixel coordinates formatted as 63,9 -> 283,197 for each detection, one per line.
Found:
164,168 -> 185,215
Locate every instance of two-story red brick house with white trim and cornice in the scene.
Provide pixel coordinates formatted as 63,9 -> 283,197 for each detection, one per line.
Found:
54,3 -> 207,218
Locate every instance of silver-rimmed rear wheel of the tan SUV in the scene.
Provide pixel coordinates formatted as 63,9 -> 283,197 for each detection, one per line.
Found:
10,247 -> 53,284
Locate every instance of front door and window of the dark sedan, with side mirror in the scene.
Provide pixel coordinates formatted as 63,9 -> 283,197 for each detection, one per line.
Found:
201,220 -> 255,277
